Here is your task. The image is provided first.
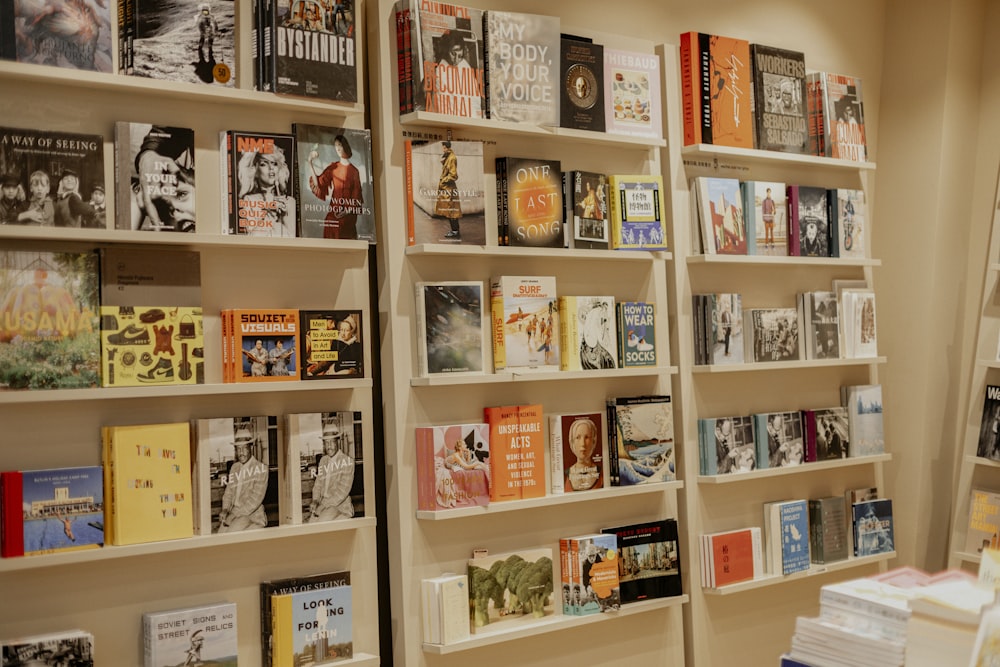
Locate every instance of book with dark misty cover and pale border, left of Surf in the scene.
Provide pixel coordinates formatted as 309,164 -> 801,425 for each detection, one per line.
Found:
414,280 -> 489,376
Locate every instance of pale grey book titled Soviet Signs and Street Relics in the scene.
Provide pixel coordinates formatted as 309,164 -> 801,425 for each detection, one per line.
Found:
142,602 -> 239,667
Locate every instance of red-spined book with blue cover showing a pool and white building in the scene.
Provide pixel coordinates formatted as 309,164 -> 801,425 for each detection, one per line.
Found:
0,466 -> 104,558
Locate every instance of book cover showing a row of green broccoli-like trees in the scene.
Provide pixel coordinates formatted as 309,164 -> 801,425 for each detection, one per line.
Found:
469,548 -> 555,634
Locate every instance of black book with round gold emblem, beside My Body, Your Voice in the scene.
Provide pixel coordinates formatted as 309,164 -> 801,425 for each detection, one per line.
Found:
559,35 -> 606,132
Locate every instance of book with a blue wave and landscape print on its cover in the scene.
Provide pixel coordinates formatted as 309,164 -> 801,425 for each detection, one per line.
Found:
607,396 -> 677,486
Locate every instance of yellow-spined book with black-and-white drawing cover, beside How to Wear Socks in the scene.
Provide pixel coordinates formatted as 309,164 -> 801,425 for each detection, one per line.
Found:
559,296 -> 618,371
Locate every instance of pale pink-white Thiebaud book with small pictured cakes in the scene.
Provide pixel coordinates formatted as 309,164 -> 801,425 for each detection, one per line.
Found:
604,48 -> 663,139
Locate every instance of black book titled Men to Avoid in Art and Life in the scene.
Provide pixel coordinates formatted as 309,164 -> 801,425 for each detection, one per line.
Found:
299,310 -> 365,380
